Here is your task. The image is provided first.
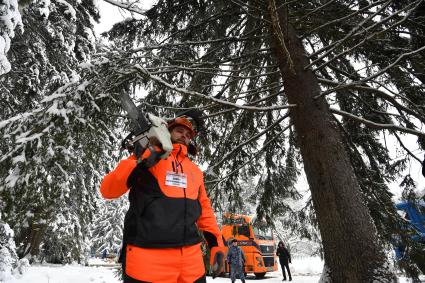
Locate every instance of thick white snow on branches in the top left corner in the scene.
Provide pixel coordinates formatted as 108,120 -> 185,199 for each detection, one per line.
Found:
0,0 -> 22,76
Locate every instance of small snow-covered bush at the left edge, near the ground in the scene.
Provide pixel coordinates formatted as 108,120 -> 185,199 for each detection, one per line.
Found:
0,218 -> 18,282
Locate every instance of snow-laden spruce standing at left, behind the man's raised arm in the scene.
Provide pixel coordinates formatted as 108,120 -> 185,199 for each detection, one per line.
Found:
0,0 -> 107,262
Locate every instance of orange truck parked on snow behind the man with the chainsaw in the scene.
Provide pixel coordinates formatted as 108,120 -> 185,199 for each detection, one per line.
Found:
211,213 -> 277,278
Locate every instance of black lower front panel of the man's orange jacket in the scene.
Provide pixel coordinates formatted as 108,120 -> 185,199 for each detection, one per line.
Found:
124,164 -> 201,248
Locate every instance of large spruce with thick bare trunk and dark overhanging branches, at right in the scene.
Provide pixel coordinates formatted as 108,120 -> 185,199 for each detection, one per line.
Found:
95,0 -> 424,282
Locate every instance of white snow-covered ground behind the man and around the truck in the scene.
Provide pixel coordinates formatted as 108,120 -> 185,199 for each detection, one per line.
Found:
1,257 -> 425,283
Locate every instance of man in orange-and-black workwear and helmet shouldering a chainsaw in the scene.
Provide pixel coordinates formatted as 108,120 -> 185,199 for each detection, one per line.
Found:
100,117 -> 224,283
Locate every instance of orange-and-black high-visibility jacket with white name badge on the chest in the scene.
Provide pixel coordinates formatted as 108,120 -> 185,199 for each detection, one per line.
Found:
100,144 -> 223,248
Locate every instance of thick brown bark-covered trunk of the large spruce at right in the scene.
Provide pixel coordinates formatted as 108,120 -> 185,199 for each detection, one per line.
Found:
269,0 -> 394,283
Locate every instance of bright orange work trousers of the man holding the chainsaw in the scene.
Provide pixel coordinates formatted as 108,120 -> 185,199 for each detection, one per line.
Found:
124,244 -> 206,283
